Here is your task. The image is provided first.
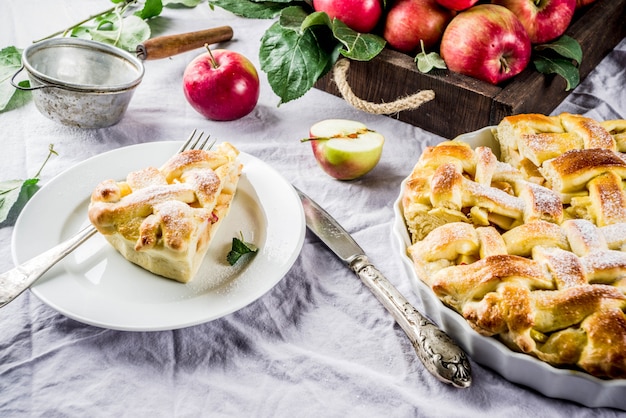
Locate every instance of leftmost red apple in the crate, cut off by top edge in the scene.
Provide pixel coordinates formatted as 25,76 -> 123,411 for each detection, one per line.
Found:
313,0 -> 383,33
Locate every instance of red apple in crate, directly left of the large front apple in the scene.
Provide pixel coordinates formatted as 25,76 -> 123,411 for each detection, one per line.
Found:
383,0 -> 455,53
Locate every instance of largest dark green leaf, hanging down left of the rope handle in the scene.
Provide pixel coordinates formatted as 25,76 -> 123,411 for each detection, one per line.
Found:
259,22 -> 333,105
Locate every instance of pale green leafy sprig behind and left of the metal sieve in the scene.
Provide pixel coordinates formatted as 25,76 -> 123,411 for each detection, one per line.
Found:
0,0 -> 206,112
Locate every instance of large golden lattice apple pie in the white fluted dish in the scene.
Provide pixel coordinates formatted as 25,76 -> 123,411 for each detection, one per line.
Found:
402,113 -> 626,378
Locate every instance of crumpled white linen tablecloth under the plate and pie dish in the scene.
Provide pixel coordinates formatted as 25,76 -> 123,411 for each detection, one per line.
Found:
0,0 -> 626,418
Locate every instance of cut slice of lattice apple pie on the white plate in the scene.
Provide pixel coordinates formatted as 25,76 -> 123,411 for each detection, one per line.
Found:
88,142 -> 242,283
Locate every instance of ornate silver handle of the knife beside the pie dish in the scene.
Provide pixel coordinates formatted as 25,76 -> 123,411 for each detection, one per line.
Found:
350,255 -> 472,388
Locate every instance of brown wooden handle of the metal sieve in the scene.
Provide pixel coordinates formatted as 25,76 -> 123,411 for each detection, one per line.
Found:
136,26 -> 233,60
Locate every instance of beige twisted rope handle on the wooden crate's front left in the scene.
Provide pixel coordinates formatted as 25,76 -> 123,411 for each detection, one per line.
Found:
333,58 -> 435,115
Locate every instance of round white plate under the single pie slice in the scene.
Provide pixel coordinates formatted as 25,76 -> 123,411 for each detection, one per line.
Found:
12,141 -> 306,331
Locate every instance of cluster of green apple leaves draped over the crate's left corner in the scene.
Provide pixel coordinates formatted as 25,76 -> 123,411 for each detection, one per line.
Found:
208,0 -> 386,105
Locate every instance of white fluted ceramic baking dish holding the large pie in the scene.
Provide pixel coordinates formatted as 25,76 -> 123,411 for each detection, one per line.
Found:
393,127 -> 626,410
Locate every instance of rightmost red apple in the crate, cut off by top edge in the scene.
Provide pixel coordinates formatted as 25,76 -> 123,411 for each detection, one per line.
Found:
492,0 -> 576,44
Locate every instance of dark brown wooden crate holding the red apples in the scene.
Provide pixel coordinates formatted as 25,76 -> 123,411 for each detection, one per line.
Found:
315,0 -> 626,138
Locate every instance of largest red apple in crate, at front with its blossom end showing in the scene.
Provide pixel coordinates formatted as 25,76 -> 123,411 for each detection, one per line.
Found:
440,4 -> 532,84
